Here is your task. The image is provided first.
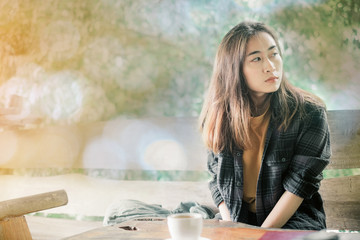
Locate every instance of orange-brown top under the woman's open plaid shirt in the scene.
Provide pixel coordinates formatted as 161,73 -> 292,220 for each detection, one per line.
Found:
243,108 -> 271,213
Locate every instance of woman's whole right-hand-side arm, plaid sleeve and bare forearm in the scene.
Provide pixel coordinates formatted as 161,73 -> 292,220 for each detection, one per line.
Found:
261,109 -> 331,228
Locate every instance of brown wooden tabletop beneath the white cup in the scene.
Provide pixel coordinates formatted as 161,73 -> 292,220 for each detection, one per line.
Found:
62,218 -> 360,240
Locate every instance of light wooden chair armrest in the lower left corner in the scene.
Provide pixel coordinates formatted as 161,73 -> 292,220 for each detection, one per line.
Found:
0,190 -> 68,240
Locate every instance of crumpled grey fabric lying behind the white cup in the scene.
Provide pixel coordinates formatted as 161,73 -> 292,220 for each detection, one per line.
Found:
103,199 -> 215,226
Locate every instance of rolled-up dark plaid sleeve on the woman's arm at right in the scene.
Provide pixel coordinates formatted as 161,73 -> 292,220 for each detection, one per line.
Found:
283,108 -> 331,199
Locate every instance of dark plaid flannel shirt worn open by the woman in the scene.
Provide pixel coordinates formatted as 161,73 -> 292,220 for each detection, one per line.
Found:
208,104 -> 331,230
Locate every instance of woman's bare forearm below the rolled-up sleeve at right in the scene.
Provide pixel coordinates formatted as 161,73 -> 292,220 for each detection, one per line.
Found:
262,191 -> 304,228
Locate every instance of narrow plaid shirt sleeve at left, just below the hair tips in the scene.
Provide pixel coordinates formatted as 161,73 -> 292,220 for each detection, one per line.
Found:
207,151 -> 224,207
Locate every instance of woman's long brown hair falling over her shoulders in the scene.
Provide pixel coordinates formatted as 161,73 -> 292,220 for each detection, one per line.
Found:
199,22 -> 324,153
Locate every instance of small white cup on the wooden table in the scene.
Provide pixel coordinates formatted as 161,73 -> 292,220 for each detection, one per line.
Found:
167,213 -> 203,240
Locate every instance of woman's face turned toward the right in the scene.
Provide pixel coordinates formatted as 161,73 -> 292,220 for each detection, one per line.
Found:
243,32 -> 283,99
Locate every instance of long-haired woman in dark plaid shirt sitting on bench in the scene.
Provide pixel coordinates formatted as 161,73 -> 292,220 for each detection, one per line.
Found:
200,22 -> 331,230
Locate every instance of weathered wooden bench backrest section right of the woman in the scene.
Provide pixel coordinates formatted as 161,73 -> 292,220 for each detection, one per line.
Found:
320,110 -> 360,230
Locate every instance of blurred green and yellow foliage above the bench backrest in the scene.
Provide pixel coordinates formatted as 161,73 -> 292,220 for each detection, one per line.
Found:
0,0 -> 360,122
